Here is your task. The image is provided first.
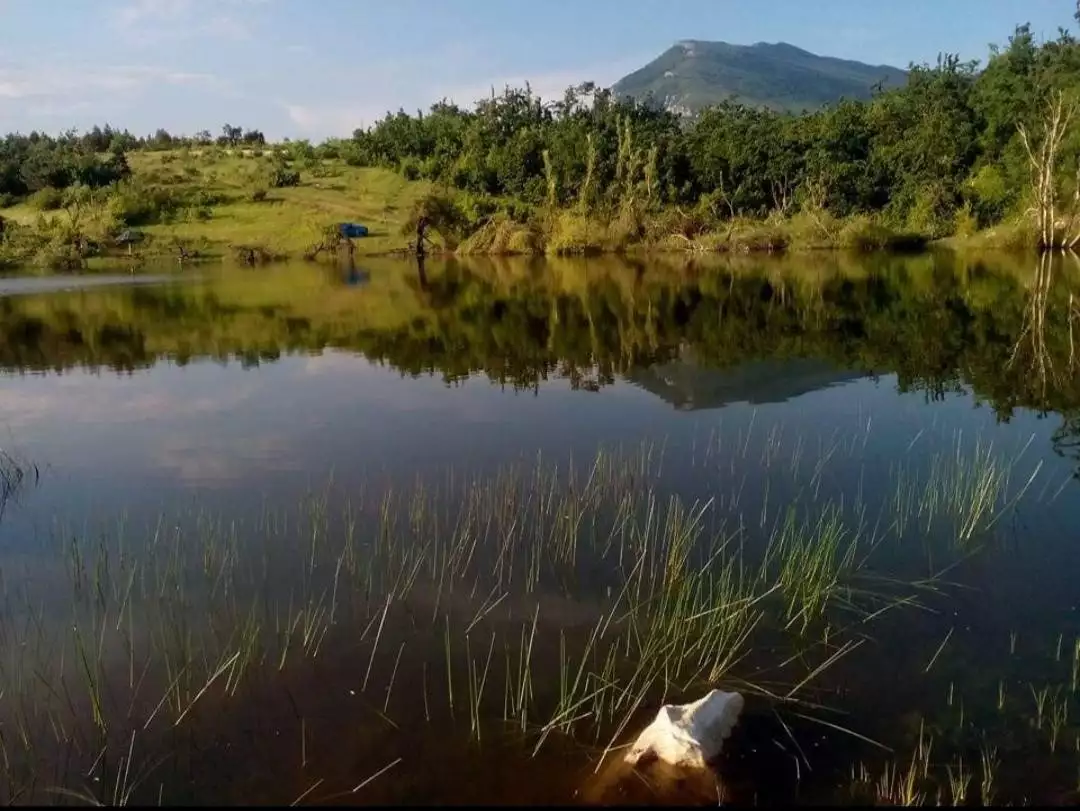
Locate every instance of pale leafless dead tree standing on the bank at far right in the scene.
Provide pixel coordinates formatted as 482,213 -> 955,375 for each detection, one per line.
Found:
1016,91 -> 1080,251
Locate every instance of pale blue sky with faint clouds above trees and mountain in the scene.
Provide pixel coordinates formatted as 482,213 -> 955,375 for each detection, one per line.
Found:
0,0 -> 1076,139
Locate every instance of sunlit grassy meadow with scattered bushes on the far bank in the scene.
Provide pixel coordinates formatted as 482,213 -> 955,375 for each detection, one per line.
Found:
0,148 -> 431,262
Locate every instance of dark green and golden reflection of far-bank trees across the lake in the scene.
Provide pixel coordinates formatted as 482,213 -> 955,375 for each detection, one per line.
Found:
6,256 -> 1080,419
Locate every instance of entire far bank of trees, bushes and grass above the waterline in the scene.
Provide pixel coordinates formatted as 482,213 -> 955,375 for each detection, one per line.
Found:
0,26 -> 1080,272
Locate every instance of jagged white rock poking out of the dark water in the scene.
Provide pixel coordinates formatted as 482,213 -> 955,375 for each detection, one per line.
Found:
624,690 -> 743,769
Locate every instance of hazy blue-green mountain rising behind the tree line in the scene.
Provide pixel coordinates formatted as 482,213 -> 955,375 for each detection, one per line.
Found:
612,40 -> 907,114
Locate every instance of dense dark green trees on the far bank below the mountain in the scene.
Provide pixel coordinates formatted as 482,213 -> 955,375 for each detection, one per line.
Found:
341,25 -> 1080,233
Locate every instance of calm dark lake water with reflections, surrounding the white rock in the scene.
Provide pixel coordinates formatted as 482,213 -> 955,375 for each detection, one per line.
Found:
0,255 -> 1080,805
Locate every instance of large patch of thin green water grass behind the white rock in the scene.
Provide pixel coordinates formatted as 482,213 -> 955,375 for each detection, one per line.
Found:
0,431 -> 1045,796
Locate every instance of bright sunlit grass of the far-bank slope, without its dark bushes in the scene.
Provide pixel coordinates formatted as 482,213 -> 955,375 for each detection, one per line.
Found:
0,152 -> 429,256
